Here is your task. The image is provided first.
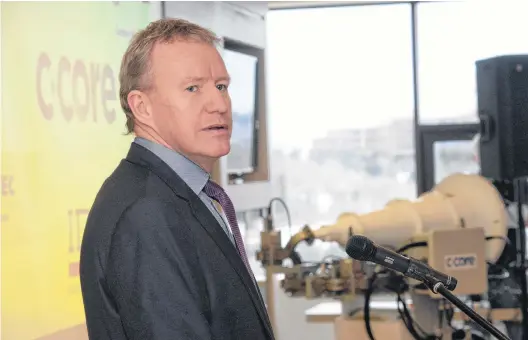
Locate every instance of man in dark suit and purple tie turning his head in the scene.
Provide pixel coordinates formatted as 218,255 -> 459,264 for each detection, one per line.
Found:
80,19 -> 274,340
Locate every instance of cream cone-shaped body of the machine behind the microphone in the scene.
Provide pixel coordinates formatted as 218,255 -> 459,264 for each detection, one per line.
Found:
287,174 -> 507,262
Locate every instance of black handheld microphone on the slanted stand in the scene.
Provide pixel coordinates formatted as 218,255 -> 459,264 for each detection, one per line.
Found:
346,235 -> 457,291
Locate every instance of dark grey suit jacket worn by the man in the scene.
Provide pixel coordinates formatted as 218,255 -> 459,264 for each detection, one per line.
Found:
80,143 -> 274,340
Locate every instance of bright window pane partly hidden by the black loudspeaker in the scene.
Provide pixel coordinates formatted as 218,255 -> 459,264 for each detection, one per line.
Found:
417,1 -> 528,124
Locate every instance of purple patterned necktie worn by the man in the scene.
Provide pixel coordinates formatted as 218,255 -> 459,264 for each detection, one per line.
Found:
204,180 -> 252,274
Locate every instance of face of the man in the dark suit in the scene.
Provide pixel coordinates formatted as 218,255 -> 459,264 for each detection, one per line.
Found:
144,41 -> 232,170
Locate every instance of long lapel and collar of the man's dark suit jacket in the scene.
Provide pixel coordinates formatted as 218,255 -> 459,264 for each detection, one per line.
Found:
126,143 -> 273,339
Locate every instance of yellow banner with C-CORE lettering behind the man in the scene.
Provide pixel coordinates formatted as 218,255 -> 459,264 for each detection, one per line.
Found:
0,2 -> 157,340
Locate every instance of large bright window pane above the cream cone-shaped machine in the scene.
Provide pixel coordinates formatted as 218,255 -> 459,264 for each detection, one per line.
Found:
267,4 -> 416,260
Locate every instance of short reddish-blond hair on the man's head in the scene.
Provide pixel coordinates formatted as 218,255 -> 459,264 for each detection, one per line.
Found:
119,19 -> 220,133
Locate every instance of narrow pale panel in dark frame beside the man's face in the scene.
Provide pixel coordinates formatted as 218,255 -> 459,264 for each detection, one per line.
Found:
223,47 -> 258,174
